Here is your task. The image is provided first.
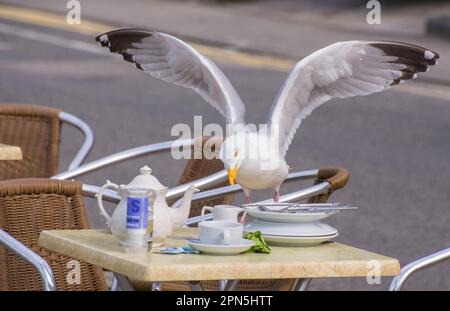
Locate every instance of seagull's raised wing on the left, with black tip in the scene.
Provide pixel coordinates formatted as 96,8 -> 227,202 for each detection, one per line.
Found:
96,29 -> 245,124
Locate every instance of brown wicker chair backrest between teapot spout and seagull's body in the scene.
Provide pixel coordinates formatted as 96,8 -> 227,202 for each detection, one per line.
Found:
178,136 -> 233,217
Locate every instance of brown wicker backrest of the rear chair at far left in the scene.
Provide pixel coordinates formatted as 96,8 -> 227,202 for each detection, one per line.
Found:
0,104 -> 61,180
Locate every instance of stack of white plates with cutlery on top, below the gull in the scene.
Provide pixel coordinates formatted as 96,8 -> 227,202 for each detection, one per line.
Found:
242,204 -> 356,246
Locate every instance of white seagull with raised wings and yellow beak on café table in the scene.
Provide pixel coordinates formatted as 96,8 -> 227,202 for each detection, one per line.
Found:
96,29 -> 439,203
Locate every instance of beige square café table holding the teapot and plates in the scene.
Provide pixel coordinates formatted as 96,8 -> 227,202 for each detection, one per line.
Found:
38,228 -> 400,290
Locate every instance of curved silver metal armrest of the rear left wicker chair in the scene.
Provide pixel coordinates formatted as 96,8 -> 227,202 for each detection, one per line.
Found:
59,112 -> 94,170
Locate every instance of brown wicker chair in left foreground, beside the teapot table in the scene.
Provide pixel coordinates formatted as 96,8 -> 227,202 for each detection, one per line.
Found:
0,179 -> 107,290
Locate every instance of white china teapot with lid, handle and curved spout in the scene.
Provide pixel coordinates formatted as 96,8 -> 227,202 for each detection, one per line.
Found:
97,166 -> 199,243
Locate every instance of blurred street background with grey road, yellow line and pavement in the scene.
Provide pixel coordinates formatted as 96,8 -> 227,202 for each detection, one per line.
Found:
0,0 -> 450,290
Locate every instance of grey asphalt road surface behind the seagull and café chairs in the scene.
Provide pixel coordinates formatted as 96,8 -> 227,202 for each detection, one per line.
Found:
0,20 -> 450,290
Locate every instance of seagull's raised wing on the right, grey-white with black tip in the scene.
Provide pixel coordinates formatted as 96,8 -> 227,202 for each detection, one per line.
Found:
269,41 -> 439,155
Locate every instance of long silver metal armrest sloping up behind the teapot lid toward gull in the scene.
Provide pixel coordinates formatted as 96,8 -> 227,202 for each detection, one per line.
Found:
51,139 -> 194,179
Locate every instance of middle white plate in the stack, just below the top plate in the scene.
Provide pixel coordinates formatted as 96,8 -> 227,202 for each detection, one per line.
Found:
244,219 -> 337,237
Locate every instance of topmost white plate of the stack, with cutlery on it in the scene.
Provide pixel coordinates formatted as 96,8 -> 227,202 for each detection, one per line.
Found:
245,207 -> 337,222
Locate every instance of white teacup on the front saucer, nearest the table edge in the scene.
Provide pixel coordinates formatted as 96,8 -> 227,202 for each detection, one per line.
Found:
198,220 -> 244,245
